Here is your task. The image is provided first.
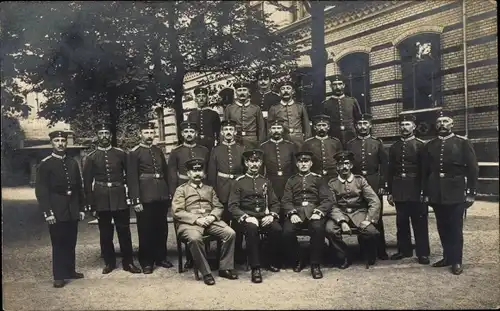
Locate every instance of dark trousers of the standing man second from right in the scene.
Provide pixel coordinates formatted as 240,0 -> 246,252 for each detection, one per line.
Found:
396,202 -> 430,257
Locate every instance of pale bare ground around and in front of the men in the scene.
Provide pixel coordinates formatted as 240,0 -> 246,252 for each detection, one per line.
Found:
2,188 -> 500,310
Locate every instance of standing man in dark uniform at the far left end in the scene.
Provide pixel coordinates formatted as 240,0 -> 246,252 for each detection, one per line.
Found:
35,131 -> 85,288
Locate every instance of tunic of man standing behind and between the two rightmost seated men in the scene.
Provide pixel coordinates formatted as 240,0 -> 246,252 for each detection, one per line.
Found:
302,136 -> 342,181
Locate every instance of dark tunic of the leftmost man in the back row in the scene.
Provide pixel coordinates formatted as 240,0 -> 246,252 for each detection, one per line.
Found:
188,107 -> 220,151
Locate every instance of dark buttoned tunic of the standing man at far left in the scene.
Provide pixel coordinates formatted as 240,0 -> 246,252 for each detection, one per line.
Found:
35,153 -> 85,222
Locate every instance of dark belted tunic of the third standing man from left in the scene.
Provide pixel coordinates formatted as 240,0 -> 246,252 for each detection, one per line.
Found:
127,144 -> 169,204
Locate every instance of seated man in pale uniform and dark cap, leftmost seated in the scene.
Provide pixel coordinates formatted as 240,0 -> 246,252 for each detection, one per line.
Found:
172,158 -> 238,285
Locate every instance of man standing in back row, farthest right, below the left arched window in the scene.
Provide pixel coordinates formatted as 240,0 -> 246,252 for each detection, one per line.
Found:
323,75 -> 361,146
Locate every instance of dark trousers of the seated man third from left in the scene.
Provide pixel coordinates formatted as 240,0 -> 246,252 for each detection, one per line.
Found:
283,218 -> 326,265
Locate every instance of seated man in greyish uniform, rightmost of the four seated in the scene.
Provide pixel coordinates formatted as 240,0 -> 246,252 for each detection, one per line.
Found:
326,151 -> 380,269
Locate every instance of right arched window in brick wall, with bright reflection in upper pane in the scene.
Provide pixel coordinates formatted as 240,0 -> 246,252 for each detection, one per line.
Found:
398,33 -> 441,110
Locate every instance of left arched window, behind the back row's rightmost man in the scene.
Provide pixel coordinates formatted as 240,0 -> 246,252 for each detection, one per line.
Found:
337,52 -> 370,113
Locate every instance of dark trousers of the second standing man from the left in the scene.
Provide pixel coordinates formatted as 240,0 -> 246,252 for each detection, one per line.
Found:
98,209 -> 133,265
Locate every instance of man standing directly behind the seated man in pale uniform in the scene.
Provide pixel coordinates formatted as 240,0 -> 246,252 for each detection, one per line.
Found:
168,121 -> 210,197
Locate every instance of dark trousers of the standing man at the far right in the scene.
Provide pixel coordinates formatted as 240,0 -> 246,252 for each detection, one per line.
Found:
432,203 -> 465,265
